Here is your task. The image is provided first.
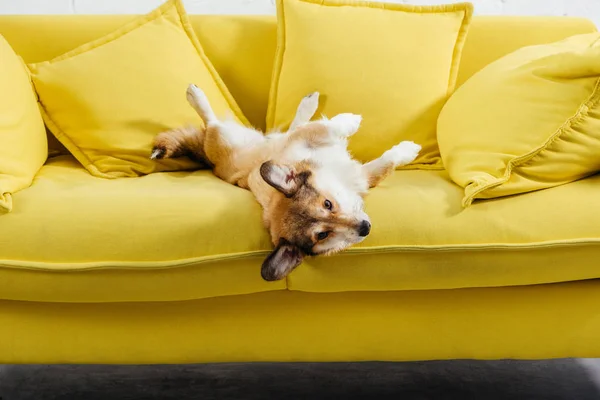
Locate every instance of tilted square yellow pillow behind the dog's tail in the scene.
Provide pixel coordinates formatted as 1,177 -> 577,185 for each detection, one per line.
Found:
29,0 -> 247,178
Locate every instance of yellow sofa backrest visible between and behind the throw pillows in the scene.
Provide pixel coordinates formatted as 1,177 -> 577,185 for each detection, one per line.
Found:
0,15 -> 596,132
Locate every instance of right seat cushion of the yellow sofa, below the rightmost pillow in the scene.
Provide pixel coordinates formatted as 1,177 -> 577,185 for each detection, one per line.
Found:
288,171 -> 600,292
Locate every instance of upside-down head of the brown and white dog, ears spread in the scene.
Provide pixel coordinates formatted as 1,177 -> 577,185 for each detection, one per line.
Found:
260,161 -> 371,281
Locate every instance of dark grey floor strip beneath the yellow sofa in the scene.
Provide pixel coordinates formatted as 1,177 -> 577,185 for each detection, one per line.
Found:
0,359 -> 600,400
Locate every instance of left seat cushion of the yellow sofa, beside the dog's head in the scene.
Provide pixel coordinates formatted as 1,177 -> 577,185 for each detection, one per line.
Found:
0,156 -> 285,302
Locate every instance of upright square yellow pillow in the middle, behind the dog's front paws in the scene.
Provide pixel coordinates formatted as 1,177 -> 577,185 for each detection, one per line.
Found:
267,0 -> 472,168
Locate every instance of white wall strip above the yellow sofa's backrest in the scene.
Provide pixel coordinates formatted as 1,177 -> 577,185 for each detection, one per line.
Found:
0,0 -> 600,26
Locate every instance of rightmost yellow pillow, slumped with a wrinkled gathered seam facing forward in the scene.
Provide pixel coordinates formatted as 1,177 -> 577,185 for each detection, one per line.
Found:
438,33 -> 600,206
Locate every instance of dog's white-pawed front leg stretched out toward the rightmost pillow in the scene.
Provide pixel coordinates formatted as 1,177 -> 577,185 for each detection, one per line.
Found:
362,141 -> 421,188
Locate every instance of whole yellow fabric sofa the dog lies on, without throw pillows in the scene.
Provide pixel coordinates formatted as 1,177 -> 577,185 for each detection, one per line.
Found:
0,16 -> 600,363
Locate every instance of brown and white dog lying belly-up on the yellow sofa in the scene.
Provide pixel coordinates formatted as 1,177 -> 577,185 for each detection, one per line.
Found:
150,85 -> 421,281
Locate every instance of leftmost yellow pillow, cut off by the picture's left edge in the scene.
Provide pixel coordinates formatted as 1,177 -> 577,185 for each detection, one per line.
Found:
0,36 -> 48,213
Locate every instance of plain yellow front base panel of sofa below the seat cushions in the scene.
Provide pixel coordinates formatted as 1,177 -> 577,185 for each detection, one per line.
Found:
0,281 -> 600,364
